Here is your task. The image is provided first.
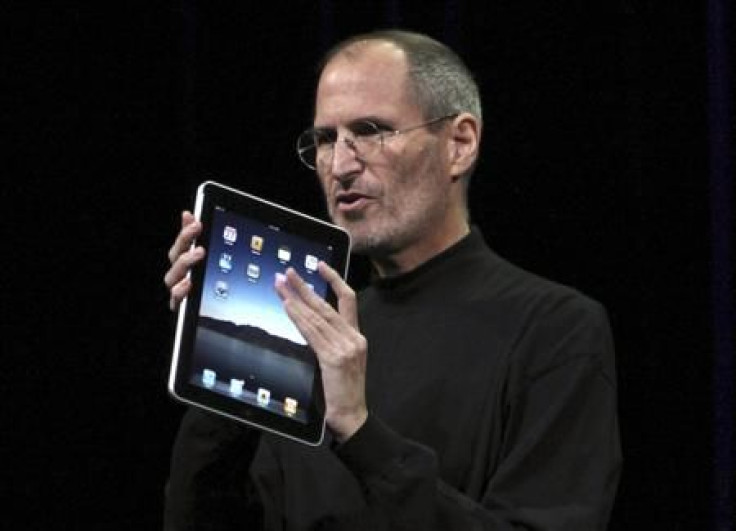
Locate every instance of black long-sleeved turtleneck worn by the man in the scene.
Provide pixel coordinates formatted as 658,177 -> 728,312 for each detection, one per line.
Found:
165,229 -> 621,531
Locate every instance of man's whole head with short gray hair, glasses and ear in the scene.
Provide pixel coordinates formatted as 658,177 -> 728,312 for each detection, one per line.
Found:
302,31 -> 481,274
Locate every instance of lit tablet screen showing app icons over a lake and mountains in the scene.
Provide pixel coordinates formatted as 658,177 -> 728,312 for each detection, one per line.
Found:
190,208 -> 332,422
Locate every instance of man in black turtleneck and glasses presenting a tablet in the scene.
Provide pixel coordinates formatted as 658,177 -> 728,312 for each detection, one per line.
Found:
165,31 -> 621,531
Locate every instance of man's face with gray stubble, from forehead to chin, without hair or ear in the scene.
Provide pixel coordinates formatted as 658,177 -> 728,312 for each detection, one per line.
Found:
314,42 -> 450,259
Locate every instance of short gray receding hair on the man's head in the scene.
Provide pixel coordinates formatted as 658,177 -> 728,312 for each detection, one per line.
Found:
319,30 -> 483,121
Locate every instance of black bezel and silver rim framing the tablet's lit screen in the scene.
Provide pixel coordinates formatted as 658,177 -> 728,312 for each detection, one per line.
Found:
168,181 -> 350,446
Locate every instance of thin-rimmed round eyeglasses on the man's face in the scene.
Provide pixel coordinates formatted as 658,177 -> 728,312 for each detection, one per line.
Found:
296,113 -> 458,170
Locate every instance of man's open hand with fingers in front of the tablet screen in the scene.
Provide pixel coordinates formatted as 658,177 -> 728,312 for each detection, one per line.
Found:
276,262 -> 368,442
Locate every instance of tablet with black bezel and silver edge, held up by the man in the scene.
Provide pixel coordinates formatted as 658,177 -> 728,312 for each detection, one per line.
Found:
169,181 -> 350,445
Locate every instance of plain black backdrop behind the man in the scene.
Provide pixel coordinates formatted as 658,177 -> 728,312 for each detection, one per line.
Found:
0,0 -> 733,531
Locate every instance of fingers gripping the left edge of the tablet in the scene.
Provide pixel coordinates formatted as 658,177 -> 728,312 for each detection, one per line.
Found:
164,210 -> 205,311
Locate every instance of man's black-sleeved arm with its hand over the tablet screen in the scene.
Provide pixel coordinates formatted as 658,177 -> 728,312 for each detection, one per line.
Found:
278,269 -> 621,531
